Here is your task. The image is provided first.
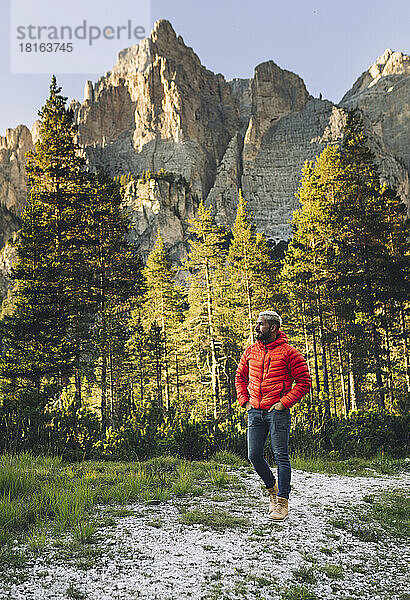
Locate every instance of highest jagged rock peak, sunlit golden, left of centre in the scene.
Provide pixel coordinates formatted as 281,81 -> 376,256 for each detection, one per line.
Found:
69,20 -> 239,197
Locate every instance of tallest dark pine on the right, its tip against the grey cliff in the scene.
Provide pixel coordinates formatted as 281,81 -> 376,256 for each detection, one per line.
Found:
332,111 -> 406,409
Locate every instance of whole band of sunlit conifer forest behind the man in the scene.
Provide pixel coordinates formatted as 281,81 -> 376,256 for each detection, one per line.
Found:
0,78 -> 410,460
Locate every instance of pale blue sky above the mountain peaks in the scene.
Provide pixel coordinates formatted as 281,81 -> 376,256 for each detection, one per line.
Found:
0,0 -> 410,135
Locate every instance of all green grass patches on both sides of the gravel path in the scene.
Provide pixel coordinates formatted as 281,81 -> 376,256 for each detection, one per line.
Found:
0,452 -> 409,593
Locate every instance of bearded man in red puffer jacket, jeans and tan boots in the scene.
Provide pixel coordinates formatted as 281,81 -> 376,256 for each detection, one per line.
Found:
235,310 -> 312,521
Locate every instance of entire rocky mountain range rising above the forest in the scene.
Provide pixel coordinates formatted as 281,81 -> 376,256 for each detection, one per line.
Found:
0,20 -> 410,278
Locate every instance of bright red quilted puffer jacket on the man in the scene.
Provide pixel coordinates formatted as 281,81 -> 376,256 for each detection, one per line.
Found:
235,330 -> 312,408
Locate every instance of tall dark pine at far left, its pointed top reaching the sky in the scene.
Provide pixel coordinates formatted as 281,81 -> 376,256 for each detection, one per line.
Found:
0,77 -> 90,390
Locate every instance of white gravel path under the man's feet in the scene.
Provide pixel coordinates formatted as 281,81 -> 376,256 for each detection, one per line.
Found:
0,468 -> 410,600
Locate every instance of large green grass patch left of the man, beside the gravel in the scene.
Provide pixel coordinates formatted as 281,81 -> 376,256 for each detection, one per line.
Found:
0,452 -> 243,571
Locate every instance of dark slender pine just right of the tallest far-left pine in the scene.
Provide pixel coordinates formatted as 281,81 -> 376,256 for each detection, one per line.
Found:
84,172 -> 144,432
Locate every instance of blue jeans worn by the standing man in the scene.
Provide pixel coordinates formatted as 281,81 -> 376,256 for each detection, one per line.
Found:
248,408 -> 291,498
